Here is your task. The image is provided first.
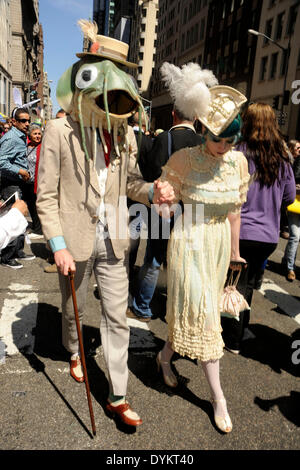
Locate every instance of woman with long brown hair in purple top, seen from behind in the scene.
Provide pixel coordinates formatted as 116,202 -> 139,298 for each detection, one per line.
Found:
222,103 -> 296,354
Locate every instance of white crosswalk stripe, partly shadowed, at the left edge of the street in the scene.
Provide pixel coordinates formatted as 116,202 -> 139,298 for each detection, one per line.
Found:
0,283 -> 38,363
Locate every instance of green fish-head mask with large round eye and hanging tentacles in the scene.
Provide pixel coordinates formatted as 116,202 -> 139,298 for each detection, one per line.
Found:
56,20 -> 147,160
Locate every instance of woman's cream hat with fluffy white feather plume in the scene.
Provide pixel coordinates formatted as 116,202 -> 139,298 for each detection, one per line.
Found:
160,62 -> 247,135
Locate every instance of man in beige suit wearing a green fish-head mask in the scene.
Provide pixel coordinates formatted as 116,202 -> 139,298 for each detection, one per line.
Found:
37,20 -> 173,426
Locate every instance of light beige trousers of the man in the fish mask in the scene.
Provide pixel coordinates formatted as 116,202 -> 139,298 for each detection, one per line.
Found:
59,224 -> 130,396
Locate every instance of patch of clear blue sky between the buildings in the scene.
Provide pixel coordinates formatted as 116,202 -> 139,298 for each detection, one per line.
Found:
39,0 -> 93,115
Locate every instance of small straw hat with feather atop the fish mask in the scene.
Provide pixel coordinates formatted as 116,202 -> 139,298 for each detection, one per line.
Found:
76,20 -> 138,68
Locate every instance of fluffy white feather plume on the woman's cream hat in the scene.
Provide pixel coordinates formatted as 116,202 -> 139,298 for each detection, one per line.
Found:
160,62 -> 218,121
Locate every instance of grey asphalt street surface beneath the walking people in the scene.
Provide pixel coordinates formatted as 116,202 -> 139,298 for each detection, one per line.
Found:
0,231 -> 300,457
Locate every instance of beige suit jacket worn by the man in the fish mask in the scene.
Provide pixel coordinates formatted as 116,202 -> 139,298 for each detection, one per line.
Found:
37,116 -> 151,261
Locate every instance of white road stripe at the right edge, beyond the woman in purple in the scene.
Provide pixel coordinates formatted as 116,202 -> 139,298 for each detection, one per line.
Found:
259,279 -> 300,324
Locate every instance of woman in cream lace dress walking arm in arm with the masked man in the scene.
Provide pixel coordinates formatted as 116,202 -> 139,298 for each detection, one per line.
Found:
154,62 -> 249,432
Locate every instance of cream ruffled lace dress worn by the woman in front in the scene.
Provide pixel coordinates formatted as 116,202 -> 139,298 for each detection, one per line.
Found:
160,146 -> 249,361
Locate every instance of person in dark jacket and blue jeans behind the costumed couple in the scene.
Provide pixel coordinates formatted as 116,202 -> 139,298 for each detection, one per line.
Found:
127,109 -> 202,322
